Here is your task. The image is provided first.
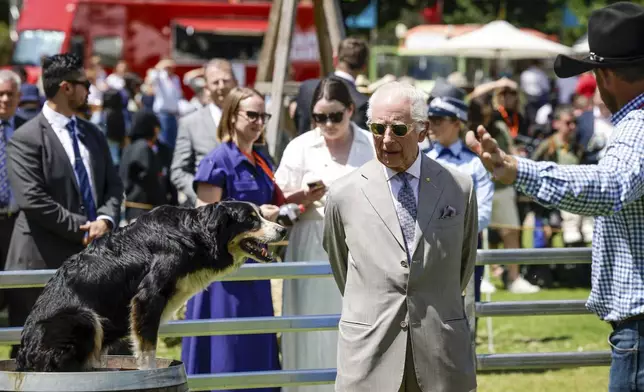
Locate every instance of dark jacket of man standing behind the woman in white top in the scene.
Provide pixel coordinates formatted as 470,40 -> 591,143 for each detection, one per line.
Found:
295,77 -> 369,135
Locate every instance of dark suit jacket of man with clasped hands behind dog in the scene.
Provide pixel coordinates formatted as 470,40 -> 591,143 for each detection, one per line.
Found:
6,113 -> 123,270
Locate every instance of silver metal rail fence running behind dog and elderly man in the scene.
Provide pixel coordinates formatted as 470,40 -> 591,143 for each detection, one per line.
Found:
0,248 -> 610,391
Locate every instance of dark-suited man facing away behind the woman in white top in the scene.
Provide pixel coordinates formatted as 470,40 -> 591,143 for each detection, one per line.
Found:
294,38 -> 369,134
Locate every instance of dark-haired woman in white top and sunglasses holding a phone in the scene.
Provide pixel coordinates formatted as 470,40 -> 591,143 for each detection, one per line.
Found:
275,76 -> 375,392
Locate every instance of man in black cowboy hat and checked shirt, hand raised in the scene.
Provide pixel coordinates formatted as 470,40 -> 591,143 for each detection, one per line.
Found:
467,2 -> 644,392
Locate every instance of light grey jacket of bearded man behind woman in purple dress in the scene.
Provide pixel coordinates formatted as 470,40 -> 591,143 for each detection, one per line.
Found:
170,105 -> 219,206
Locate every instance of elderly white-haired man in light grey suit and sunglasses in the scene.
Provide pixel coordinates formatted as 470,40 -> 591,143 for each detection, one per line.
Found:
323,82 -> 477,392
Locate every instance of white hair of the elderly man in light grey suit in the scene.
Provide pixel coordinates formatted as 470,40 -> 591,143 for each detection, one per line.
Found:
367,81 -> 427,132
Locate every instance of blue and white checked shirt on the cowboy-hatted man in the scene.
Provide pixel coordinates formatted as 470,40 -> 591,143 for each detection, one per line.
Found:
515,94 -> 644,321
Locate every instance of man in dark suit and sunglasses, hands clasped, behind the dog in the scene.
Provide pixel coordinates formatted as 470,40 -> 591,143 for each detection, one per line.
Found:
6,54 -> 123,356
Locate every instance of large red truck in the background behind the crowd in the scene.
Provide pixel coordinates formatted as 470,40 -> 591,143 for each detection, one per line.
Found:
12,0 -> 320,93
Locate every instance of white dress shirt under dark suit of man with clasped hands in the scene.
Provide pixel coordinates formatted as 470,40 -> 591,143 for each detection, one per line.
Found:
42,102 -> 114,227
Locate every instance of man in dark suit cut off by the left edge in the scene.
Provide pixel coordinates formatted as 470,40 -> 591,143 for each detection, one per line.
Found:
0,70 -> 25,308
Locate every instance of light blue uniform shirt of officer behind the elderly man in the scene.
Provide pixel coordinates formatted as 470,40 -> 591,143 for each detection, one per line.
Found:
423,139 -> 494,233
